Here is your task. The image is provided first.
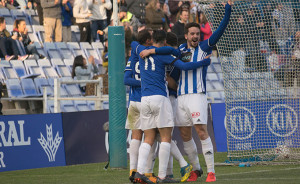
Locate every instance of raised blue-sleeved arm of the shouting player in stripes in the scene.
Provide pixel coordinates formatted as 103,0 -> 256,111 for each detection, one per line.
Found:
207,1 -> 233,47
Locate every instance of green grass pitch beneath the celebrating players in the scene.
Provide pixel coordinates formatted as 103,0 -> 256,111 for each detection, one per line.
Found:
0,153 -> 300,184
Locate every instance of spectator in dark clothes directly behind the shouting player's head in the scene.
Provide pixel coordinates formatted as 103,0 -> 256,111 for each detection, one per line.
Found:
172,9 -> 189,45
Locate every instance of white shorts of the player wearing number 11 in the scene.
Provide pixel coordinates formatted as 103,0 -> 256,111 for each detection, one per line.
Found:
141,95 -> 174,130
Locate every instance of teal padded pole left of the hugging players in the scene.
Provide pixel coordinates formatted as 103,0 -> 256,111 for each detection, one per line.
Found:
108,26 -> 127,168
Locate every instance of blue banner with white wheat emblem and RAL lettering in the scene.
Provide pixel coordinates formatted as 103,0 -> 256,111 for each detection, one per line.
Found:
0,114 -> 66,172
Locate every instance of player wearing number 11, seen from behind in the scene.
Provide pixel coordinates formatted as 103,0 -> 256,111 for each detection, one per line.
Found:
135,30 -> 210,184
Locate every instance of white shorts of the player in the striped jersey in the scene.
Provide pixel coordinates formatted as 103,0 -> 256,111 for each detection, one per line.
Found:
176,93 -> 207,126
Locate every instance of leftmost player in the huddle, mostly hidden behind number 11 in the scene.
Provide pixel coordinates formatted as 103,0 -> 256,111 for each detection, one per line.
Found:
124,29 -> 152,182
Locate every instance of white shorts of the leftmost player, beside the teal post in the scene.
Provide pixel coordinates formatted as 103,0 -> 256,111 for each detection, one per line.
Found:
125,101 -> 141,130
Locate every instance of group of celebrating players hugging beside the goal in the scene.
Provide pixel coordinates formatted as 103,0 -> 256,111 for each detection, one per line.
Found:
124,0 -> 233,184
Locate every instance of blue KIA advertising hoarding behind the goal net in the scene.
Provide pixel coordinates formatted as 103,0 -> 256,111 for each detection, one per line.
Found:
212,99 -> 300,151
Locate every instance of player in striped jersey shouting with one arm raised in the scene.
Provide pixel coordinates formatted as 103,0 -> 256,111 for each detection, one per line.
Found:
140,0 -> 233,182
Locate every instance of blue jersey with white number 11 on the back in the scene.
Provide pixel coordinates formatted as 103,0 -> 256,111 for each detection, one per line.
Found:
138,46 -> 175,97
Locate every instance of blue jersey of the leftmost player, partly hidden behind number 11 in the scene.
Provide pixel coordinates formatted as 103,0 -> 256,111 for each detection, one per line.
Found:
124,44 -> 141,102
